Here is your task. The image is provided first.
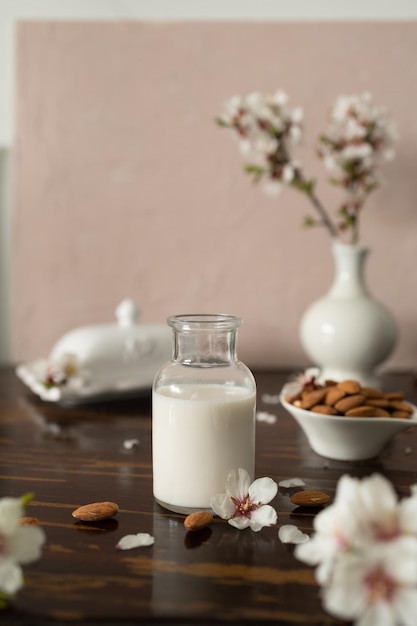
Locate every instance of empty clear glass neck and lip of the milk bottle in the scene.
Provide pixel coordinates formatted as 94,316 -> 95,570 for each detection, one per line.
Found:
168,315 -> 241,367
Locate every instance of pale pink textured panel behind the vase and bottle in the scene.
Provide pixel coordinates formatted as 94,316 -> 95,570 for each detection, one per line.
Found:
12,22 -> 417,367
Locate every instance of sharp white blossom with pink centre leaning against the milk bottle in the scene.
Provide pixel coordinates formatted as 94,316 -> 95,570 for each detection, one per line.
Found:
210,468 -> 278,532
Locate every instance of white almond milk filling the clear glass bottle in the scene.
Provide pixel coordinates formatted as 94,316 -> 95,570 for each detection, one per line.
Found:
152,383 -> 256,512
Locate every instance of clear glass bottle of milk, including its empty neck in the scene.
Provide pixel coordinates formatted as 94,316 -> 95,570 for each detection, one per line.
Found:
152,314 -> 256,514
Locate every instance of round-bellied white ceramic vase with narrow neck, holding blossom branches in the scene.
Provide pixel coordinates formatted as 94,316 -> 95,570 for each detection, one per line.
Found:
300,242 -> 398,386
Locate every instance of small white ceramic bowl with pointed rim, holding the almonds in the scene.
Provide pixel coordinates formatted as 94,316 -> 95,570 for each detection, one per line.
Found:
280,387 -> 417,461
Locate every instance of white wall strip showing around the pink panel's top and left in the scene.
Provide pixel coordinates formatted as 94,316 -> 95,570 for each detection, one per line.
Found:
0,0 -> 417,363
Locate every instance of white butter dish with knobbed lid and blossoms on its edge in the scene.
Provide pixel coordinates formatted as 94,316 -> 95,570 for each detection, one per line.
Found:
16,299 -> 171,404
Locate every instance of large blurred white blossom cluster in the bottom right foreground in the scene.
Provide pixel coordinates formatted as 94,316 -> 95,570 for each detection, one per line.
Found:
295,474 -> 417,626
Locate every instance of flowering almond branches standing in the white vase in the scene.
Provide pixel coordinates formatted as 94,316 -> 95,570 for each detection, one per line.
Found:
217,90 -> 397,244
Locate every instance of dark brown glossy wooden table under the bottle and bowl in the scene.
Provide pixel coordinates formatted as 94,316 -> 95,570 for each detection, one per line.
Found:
0,368 -> 417,626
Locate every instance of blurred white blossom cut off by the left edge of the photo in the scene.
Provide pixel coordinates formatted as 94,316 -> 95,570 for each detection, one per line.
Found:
0,497 -> 45,595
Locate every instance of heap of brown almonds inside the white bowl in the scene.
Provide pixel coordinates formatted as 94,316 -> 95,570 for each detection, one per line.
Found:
285,380 -> 414,419
